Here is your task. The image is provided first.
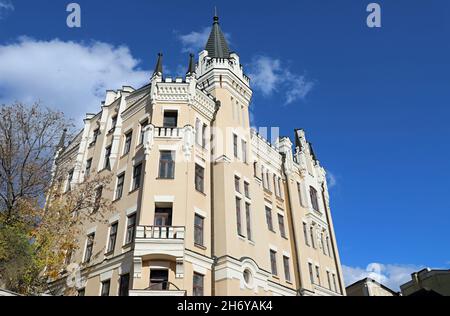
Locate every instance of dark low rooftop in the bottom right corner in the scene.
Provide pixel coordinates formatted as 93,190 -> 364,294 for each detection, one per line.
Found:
400,269 -> 450,296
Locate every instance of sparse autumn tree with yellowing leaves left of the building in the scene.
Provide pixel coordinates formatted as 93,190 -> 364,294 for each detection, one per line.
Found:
0,103 -> 113,294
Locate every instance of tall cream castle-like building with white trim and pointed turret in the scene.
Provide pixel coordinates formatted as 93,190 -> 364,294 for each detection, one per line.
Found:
49,17 -> 345,296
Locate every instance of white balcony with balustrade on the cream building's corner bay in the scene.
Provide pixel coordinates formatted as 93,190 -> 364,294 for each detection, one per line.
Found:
135,226 -> 186,259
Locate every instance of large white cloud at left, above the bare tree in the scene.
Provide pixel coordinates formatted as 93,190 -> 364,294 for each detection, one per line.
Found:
0,37 -> 150,119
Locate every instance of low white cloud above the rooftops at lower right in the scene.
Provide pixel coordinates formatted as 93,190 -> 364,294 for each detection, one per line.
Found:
342,263 -> 424,291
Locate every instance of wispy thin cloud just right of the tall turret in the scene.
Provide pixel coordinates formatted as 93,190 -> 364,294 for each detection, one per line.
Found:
249,56 -> 314,105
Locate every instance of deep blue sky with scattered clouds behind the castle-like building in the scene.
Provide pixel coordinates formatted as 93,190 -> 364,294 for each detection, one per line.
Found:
0,0 -> 450,287
